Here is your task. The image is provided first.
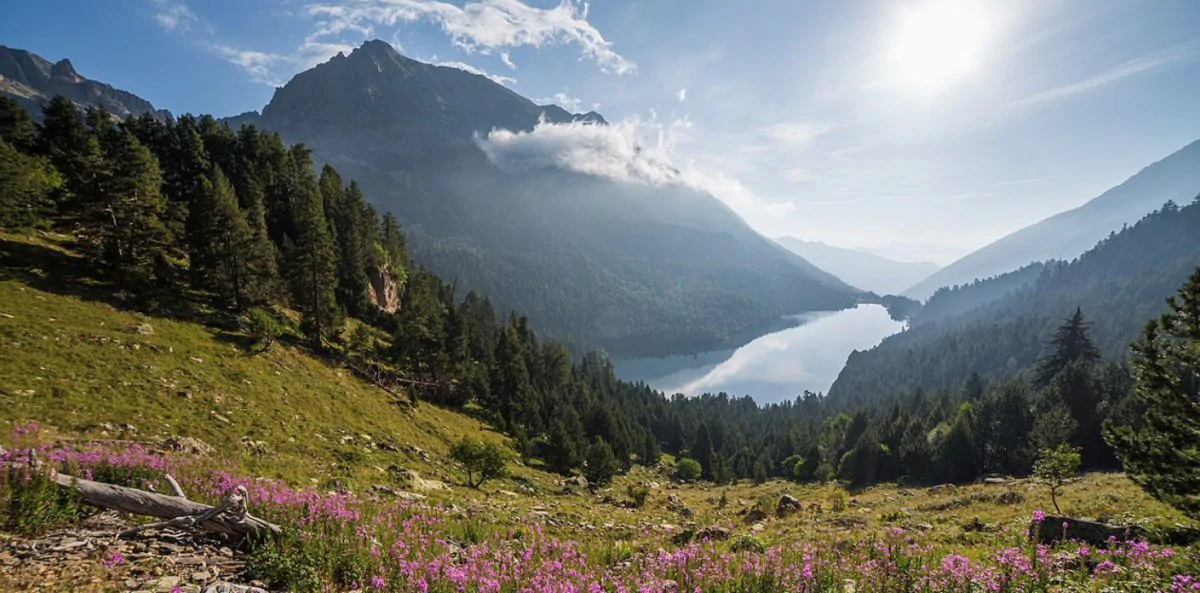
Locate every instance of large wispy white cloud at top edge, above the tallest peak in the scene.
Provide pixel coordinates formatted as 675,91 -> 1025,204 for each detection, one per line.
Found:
307,0 -> 637,74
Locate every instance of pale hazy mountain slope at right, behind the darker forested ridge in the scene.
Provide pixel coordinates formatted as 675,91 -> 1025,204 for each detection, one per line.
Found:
904,140 -> 1200,300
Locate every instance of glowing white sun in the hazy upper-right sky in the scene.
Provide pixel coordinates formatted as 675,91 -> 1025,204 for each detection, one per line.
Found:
892,0 -> 988,91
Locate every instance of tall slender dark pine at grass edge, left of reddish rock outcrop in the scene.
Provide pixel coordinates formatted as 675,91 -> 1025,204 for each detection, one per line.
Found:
288,187 -> 341,351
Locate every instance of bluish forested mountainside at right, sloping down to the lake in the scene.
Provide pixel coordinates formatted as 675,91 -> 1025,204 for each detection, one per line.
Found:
829,199 -> 1200,407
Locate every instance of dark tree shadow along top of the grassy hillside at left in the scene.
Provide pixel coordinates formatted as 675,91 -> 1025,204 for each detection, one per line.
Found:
0,238 -> 238,331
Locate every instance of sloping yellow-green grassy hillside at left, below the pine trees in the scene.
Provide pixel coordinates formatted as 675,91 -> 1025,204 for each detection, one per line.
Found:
0,234 -> 548,492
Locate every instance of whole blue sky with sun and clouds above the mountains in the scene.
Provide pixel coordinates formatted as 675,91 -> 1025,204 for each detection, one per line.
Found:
0,0 -> 1200,264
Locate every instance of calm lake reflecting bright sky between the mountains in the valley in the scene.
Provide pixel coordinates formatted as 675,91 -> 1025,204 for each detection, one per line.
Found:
614,305 -> 904,403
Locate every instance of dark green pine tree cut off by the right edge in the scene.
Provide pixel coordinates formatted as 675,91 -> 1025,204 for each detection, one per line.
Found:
1106,269 -> 1200,519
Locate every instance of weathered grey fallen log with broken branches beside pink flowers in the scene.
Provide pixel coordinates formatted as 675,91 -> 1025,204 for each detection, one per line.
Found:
52,472 -> 280,539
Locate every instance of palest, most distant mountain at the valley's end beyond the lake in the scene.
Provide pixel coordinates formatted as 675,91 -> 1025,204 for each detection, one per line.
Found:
775,236 -> 938,294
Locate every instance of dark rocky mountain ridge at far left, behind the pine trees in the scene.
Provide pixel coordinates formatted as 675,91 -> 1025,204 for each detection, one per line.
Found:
0,46 -> 170,119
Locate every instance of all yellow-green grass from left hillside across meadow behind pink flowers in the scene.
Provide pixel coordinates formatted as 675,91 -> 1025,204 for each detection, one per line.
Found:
0,228 -> 1190,593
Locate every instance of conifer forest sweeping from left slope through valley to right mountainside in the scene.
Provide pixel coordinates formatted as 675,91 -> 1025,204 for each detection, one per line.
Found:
0,97 -> 1200,497
